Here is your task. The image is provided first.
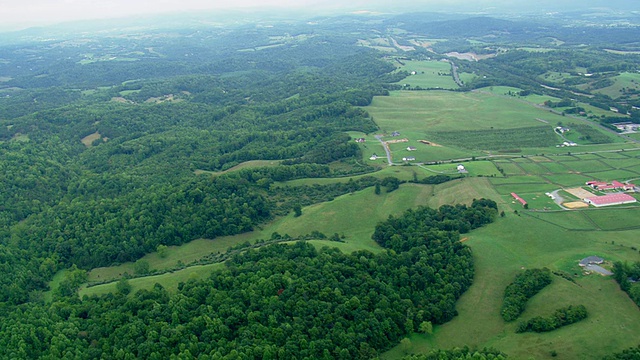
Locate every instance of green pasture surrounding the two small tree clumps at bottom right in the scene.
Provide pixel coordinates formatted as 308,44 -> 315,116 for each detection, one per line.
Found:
382,212 -> 640,359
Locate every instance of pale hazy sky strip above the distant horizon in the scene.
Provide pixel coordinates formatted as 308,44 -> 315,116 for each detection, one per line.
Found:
0,0 -> 640,29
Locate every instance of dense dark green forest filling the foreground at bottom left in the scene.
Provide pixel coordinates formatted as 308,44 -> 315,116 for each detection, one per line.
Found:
0,200 -> 497,359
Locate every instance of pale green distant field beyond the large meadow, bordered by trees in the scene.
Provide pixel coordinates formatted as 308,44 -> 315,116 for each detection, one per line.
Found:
398,60 -> 458,89
